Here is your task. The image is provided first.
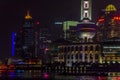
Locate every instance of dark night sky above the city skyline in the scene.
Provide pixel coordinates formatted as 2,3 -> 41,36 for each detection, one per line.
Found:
0,0 -> 120,58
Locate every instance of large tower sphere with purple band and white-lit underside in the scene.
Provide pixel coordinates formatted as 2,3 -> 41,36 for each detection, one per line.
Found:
76,22 -> 97,39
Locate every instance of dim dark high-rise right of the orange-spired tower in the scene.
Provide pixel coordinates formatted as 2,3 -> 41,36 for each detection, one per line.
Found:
38,25 -> 52,64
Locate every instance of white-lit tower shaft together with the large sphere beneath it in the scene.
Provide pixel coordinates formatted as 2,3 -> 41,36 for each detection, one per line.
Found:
76,0 -> 97,42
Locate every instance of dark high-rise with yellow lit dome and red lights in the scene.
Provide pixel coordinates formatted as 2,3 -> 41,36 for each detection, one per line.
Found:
96,4 -> 117,41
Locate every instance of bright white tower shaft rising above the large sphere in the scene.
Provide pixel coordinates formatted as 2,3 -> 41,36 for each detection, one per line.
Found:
81,0 -> 92,20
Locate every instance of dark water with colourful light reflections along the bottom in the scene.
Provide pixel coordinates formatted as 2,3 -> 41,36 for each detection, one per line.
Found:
0,70 -> 120,80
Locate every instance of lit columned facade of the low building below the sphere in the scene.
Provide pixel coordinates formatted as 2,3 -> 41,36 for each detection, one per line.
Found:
58,43 -> 101,66
